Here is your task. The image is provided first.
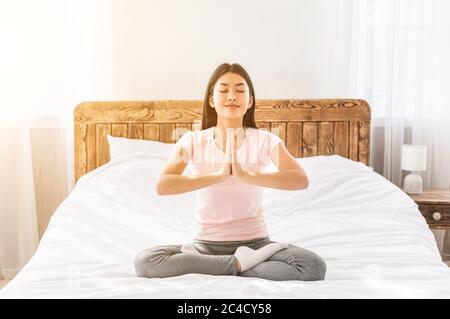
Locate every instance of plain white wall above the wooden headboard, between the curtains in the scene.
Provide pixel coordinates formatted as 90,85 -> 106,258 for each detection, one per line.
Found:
94,0 -> 356,99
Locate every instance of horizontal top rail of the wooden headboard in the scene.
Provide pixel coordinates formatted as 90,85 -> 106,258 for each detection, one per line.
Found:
74,99 -> 370,124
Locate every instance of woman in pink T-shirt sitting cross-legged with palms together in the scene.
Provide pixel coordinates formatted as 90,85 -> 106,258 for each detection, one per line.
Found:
135,63 -> 326,281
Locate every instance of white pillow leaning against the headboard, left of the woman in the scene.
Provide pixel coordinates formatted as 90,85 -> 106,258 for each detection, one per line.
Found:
106,135 -> 175,160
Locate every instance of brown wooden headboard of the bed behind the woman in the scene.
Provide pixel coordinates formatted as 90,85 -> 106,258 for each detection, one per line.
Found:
74,99 -> 370,181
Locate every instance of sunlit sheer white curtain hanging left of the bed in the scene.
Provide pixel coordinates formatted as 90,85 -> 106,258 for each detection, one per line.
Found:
0,0 -> 103,279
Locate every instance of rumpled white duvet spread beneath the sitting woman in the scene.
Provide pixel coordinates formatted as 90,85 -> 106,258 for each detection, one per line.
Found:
0,155 -> 450,298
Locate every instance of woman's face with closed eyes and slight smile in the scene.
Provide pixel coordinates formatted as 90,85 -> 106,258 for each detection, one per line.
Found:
209,72 -> 253,118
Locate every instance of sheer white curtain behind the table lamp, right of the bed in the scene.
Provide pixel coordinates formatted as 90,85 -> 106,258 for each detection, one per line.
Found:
349,0 -> 450,188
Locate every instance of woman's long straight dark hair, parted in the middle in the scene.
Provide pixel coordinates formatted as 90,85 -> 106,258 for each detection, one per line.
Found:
202,63 -> 258,130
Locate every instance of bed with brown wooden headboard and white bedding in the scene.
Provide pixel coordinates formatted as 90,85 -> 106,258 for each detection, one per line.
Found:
0,99 -> 450,298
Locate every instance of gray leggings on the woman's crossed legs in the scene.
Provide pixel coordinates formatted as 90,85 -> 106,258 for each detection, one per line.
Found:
134,237 -> 326,281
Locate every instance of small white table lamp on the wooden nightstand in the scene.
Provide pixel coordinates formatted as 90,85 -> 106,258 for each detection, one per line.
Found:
401,144 -> 427,194
